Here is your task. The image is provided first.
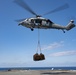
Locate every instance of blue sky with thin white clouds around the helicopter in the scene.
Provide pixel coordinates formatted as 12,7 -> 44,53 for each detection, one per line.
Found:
0,0 -> 76,67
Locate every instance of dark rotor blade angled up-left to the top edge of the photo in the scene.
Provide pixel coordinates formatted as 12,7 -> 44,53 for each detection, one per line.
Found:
14,0 -> 37,15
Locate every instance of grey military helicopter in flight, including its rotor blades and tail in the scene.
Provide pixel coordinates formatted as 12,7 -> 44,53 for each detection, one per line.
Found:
14,0 -> 76,33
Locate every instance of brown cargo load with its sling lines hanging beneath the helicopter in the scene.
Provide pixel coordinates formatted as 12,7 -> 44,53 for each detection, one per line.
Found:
33,29 -> 45,61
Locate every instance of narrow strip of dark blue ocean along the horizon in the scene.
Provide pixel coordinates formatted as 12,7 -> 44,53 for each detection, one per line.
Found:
0,67 -> 76,71
